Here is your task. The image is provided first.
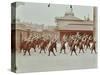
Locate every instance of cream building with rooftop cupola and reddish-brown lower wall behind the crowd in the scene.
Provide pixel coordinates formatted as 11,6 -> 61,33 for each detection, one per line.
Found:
55,6 -> 94,38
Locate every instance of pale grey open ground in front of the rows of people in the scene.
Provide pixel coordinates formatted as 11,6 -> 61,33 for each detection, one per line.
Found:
16,44 -> 97,72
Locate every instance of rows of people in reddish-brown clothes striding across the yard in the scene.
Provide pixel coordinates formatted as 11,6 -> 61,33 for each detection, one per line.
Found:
20,33 -> 97,56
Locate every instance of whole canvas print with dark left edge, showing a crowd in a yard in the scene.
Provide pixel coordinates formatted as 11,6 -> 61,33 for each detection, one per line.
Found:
11,2 -> 98,73
